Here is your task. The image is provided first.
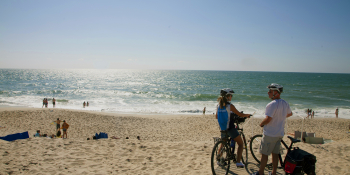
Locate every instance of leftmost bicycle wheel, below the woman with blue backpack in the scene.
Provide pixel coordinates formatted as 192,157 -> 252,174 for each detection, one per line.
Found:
211,141 -> 230,175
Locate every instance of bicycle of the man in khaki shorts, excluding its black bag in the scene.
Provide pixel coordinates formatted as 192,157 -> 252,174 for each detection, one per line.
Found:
250,135 -> 314,174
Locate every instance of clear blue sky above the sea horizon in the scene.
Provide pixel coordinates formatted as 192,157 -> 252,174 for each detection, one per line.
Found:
0,0 -> 350,73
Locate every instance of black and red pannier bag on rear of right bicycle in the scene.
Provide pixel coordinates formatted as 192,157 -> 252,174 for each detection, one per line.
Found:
284,147 -> 317,175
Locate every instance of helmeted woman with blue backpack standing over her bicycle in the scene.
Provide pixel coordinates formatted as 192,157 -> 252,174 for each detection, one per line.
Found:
216,89 -> 251,168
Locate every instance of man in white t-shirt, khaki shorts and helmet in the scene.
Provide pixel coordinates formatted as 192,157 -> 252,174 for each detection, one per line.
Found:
252,83 -> 293,175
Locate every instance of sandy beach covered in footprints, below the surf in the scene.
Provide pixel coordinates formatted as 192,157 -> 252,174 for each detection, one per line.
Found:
0,108 -> 350,175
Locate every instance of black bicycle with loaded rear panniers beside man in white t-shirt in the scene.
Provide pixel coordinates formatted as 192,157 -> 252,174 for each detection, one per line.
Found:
250,135 -> 316,174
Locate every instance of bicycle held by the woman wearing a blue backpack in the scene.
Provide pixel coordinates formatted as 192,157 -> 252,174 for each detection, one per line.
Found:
211,111 -> 248,175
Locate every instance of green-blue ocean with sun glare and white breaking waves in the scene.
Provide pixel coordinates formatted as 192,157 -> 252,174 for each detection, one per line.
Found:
0,69 -> 350,118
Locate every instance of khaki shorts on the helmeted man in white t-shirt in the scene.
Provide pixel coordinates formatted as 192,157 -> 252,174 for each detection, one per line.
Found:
259,135 -> 282,155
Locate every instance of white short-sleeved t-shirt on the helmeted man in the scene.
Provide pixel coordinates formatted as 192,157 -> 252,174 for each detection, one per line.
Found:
263,99 -> 292,137
